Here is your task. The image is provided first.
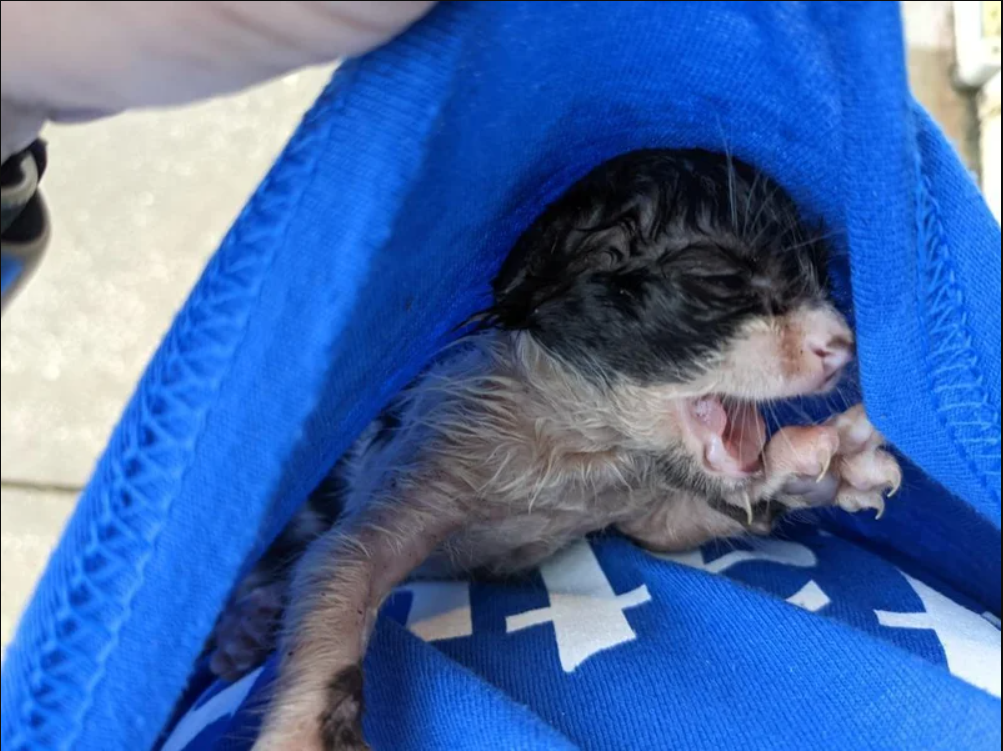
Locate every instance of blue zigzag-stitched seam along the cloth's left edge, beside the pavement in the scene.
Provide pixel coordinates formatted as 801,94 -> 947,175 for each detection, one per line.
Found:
5,67 -> 351,751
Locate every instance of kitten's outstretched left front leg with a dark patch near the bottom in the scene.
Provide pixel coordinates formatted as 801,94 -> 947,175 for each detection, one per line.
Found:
254,499 -> 462,751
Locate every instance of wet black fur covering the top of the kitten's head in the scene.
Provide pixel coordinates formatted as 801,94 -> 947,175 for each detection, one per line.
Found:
488,150 -> 827,385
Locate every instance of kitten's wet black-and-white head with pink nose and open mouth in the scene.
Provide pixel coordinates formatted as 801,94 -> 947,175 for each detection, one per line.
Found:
491,150 -> 853,477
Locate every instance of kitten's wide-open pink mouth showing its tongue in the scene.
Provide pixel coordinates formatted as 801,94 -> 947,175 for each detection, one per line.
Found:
685,394 -> 766,476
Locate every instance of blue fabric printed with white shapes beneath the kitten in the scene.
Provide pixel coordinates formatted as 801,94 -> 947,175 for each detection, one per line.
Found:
160,529 -> 1000,751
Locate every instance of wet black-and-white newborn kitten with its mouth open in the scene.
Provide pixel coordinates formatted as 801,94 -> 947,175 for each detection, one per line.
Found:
212,150 -> 901,751
